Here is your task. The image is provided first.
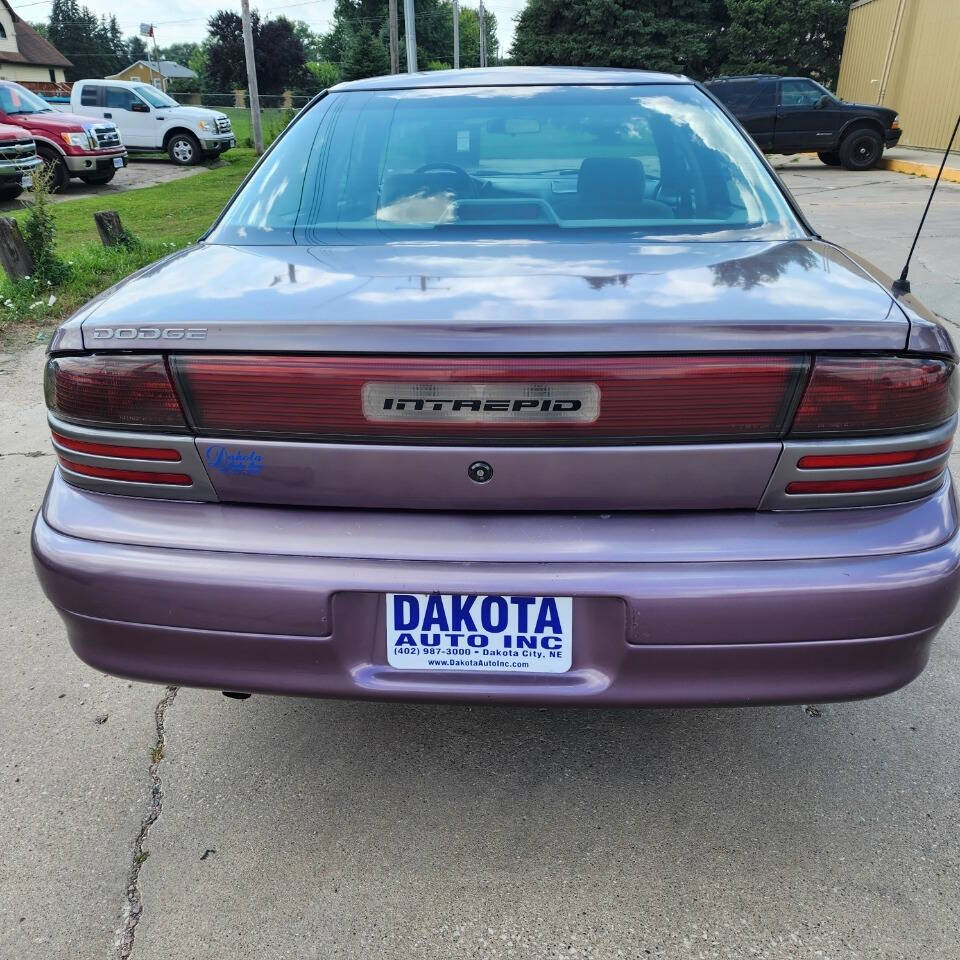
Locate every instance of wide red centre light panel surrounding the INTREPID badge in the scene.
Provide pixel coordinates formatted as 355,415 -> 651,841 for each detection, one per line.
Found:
172,355 -> 803,443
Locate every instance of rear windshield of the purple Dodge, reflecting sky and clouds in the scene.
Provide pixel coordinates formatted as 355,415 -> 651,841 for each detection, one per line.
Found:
209,84 -> 804,244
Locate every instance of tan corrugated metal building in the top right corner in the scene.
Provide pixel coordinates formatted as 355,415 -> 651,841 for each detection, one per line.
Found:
837,0 -> 960,150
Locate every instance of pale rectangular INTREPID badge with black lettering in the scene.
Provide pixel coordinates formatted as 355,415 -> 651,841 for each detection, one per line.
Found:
363,382 -> 600,423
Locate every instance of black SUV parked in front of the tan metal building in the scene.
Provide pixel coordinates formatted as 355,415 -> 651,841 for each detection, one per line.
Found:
705,74 -> 902,170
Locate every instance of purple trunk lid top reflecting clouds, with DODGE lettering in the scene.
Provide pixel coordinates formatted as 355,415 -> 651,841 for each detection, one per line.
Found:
82,240 -> 909,354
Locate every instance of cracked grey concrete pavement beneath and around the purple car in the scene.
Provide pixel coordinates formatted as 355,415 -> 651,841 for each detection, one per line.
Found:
0,163 -> 960,960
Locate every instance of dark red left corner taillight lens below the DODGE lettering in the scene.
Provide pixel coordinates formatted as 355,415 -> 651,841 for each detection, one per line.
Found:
44,355 -> 186,432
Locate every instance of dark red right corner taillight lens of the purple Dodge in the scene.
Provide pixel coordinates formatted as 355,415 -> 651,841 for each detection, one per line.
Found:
790,357 -> 957,437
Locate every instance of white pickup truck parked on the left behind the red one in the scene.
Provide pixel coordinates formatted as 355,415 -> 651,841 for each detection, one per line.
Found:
70,80 -> 237,166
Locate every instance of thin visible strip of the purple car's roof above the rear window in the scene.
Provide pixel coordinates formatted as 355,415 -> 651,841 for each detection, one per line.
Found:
330,67 -> 692,91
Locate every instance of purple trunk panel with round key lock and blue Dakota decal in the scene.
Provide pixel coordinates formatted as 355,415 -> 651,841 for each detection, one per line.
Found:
197,437 -> 781,510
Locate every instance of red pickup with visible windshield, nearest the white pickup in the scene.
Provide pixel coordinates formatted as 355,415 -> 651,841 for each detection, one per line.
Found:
0,80 -> 127,192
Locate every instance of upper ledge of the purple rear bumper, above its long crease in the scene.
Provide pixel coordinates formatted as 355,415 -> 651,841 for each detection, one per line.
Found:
43,471 -> 957,565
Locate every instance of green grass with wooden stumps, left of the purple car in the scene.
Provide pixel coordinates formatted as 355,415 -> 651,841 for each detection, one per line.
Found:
0,148 -> 255,342
